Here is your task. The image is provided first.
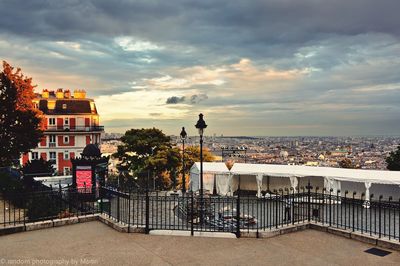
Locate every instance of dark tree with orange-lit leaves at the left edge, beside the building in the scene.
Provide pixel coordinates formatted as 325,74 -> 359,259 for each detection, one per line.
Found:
0,61 -> 43,166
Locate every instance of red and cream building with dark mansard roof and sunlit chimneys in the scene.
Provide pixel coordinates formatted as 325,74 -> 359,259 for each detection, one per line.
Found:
21,89 -> 104,175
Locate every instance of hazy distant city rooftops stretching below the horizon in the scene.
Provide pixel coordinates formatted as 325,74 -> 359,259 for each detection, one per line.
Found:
101,133 -> 400,170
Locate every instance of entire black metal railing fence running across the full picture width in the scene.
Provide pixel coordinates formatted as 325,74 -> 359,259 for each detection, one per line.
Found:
0,186 -> 400,241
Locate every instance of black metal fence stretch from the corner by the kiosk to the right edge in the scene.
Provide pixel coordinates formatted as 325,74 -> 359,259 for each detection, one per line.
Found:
101,186 -> 400,241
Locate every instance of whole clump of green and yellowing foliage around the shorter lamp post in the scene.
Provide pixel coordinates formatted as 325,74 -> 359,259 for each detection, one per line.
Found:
110,128 -> 214,189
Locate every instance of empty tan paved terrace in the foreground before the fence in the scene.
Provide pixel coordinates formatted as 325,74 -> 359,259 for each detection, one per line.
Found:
0,221 -> 400,265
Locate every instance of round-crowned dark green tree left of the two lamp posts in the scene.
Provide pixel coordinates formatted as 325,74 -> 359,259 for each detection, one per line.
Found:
114,128 -> 180,187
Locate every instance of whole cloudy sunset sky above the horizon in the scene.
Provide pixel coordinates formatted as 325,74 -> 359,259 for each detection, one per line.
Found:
0,0 -> 400,136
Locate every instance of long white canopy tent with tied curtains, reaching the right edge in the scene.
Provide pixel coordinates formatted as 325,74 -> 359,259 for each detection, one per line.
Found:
230,163 -> 400,198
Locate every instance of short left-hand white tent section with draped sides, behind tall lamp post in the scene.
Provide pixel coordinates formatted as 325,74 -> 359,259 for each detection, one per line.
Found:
189,162 -> 231,195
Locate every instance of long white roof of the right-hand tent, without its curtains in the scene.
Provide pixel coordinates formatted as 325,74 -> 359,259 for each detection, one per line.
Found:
231,163 -> 400,185
